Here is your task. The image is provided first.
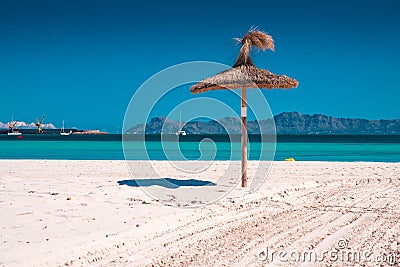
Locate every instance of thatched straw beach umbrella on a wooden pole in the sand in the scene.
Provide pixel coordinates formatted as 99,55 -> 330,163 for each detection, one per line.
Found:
190,30 -> 298,187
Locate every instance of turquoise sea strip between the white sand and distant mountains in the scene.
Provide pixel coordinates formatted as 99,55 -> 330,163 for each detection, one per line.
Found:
0,135 -> 400,162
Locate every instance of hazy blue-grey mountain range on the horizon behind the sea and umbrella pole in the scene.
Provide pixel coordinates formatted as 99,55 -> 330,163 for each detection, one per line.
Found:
127,112 -> 400,135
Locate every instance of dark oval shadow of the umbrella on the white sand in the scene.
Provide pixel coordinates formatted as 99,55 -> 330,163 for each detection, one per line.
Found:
118,178 -> 216,189
